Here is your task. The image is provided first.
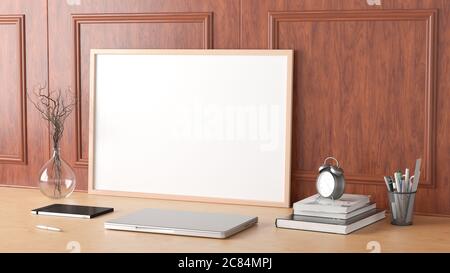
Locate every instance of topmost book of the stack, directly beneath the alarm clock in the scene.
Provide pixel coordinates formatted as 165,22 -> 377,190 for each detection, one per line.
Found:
294,194 -> 370,213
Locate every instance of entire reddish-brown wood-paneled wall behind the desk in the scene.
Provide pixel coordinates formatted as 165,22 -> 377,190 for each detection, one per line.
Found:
0,0 -> 450,215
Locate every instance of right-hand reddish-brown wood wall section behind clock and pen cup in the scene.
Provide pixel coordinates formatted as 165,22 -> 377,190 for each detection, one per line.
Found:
241,0 -> 450,214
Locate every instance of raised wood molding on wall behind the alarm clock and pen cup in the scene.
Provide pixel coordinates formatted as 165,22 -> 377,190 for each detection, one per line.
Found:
268,9 -> 438,188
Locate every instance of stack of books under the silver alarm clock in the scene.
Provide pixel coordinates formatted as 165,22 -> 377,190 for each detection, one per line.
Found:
275,194 -> 386,234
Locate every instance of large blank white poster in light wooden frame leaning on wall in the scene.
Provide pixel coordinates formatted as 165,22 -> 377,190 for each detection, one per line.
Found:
89,49 -> 292,206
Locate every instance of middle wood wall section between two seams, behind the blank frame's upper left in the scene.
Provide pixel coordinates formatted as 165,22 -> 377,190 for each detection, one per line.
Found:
49,0 -> 239,190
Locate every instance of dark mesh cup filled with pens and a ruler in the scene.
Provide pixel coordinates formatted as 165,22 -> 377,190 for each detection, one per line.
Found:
384,158 -> 421,226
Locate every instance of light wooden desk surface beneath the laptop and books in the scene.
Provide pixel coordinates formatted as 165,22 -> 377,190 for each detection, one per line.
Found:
0,187 -> 450,252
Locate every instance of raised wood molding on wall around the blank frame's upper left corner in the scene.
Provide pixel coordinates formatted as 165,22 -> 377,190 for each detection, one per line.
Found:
72,12 -> 213,168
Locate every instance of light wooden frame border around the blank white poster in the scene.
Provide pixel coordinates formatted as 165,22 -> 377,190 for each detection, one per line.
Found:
88,49 -> 294,207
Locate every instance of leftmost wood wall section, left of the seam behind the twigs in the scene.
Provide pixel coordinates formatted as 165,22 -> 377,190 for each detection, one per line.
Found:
0,0 -> 49,187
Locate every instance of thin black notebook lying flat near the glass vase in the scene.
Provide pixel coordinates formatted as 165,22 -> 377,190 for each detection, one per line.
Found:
31,204 -> 114,219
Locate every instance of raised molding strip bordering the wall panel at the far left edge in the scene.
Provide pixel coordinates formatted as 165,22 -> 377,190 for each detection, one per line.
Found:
0,14 -> 28,164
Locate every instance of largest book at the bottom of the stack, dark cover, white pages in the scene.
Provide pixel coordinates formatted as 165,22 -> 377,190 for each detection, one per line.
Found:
275,210 -> 386,234
